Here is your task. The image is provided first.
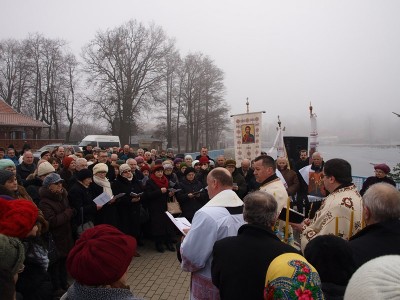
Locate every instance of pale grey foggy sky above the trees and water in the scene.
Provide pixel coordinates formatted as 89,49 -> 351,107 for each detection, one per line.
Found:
0,0 -> 400,143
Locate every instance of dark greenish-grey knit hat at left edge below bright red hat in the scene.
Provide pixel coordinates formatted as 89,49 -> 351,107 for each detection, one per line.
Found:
0,234 -> 25,275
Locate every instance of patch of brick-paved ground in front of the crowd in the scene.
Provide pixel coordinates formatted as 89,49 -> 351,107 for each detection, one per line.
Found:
128,240 -> 190,300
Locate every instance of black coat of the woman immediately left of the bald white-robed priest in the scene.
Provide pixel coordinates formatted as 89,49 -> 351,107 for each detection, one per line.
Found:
176,178 -> 209,222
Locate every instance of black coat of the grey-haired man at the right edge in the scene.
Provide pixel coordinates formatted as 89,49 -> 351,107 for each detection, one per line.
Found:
349,219 -> 400,268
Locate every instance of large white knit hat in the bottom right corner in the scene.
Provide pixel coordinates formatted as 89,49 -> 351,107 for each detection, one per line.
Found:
344,255 -> 400,300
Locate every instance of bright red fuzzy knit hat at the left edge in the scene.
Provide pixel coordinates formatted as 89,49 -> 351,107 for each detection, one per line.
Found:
0,198 -> 39,238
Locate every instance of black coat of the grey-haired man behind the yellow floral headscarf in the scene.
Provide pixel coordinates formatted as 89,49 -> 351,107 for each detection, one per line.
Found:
211,224 -> 299,300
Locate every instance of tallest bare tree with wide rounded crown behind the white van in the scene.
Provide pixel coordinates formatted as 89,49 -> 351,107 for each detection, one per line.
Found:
83,21 -> 173,143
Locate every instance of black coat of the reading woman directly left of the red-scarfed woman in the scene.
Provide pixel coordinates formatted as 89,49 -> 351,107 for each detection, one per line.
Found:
111,175 -> 142,238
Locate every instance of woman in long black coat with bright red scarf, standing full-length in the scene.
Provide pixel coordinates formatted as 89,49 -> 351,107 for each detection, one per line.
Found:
145,165 -> 175,252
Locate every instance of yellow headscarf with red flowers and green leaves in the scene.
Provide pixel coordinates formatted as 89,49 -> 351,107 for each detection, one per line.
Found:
264,253 -> 325,300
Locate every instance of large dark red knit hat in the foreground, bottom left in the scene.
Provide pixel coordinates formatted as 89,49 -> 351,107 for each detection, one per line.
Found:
67,225 -> 136,286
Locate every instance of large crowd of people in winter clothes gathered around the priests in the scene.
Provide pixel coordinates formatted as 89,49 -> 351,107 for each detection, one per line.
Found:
0,145 -> 400,300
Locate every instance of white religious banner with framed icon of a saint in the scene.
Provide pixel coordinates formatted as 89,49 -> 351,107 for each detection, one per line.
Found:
232,112 -> 262,167
